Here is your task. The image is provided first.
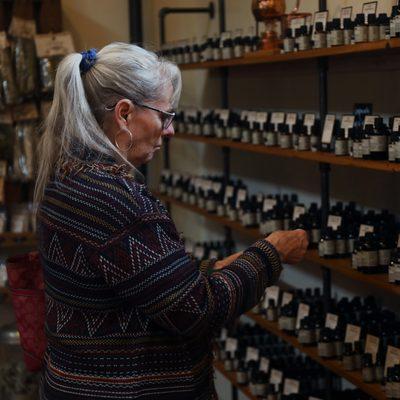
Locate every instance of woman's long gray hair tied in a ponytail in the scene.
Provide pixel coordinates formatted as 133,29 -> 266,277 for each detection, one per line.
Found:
34,43 -> 182,202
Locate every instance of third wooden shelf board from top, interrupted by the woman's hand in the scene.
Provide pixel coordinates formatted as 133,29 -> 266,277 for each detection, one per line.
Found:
155,193 -> 400,296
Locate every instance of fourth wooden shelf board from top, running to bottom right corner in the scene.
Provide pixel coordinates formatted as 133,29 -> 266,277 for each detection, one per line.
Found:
246,313 -> 386,399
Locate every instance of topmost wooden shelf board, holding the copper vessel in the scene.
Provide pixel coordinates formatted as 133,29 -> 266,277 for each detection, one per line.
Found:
179,39 -> 392,70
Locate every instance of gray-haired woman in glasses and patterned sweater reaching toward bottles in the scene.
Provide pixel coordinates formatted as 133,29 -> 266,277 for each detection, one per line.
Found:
35,43 -> 307,400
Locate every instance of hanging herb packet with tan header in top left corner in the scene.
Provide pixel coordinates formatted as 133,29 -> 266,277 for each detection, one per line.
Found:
9,0 -> 37,97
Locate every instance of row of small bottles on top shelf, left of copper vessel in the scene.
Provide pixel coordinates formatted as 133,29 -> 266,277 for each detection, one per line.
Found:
159,27 -> 260,64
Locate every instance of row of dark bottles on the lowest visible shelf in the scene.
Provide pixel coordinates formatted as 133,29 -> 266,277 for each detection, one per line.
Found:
216,323 -> 369,400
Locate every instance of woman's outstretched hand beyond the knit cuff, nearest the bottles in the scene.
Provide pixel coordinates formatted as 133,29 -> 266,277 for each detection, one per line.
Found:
265,229 -> 308,264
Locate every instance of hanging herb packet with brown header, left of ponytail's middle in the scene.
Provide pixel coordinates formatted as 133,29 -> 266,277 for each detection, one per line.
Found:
13,103 -> 39,180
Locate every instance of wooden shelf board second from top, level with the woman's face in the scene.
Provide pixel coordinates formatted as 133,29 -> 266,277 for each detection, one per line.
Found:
175,133 -> 400,172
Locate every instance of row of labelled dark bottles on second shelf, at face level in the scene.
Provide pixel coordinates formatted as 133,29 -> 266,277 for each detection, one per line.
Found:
175,109 -> 400,162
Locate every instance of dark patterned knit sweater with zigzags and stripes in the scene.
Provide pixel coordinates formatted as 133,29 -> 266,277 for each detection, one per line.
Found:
38,163 -> 281,400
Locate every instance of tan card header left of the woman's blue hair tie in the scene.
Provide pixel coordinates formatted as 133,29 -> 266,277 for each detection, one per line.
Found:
35,32 -> 75,58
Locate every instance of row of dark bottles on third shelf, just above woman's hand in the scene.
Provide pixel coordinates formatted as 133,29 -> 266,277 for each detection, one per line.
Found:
159,171 -> 400,283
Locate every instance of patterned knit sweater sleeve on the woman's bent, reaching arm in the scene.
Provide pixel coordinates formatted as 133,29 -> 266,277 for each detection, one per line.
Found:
94,214 -> 281,336
